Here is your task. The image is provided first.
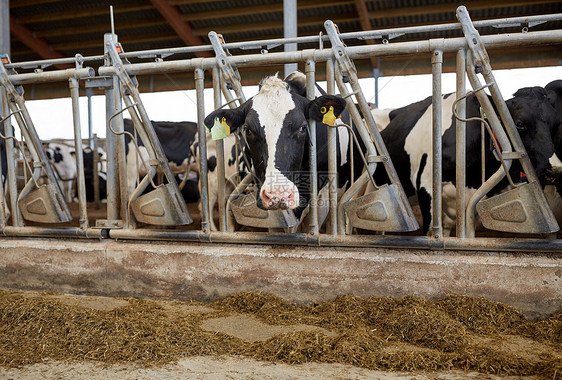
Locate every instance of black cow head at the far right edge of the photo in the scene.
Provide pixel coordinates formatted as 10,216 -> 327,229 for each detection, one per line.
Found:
506,87 -> 560,186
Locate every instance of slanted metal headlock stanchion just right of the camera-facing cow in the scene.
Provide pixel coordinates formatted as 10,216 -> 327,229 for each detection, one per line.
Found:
324,20 -> 419,233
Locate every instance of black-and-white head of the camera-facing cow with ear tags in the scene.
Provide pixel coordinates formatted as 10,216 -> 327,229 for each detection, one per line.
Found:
205,72 -> 345,210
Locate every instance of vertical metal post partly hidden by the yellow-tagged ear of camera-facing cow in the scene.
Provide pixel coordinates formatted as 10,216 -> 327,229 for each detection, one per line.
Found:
305,60 -> 318,235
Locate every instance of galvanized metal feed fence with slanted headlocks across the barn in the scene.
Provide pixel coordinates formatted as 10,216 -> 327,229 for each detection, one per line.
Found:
0,7 -> 562,251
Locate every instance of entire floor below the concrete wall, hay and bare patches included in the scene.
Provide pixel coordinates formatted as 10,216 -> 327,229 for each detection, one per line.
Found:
0,290 -> 562,380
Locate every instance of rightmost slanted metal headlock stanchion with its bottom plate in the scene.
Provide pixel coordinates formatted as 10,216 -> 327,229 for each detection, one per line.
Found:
457,6 -> 559,237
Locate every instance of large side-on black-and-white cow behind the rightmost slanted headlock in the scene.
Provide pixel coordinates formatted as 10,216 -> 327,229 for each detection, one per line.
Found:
373,87 -> 558,234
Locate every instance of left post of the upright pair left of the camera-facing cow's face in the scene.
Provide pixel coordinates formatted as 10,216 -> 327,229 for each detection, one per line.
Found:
195,68 -> 210,233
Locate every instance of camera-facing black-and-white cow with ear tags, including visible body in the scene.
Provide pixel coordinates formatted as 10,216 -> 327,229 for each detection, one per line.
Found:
205,72 -> 362,226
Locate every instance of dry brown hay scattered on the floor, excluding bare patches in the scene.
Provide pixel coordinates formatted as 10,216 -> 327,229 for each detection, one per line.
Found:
0,290 -> 562,379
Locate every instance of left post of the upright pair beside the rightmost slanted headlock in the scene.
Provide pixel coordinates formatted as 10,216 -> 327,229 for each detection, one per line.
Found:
431,50 -> 443,239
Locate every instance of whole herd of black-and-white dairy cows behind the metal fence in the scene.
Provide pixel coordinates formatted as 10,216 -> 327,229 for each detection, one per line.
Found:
5,72 -> 562,234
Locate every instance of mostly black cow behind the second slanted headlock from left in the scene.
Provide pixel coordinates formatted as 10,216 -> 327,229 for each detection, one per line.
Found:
124,119 -> 199,203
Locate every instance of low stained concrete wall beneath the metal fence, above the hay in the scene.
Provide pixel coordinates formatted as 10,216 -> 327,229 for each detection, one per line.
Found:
0,238 -> 562,319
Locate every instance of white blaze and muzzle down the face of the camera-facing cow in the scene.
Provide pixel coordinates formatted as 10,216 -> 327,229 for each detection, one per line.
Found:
252,77 -> 299,209
